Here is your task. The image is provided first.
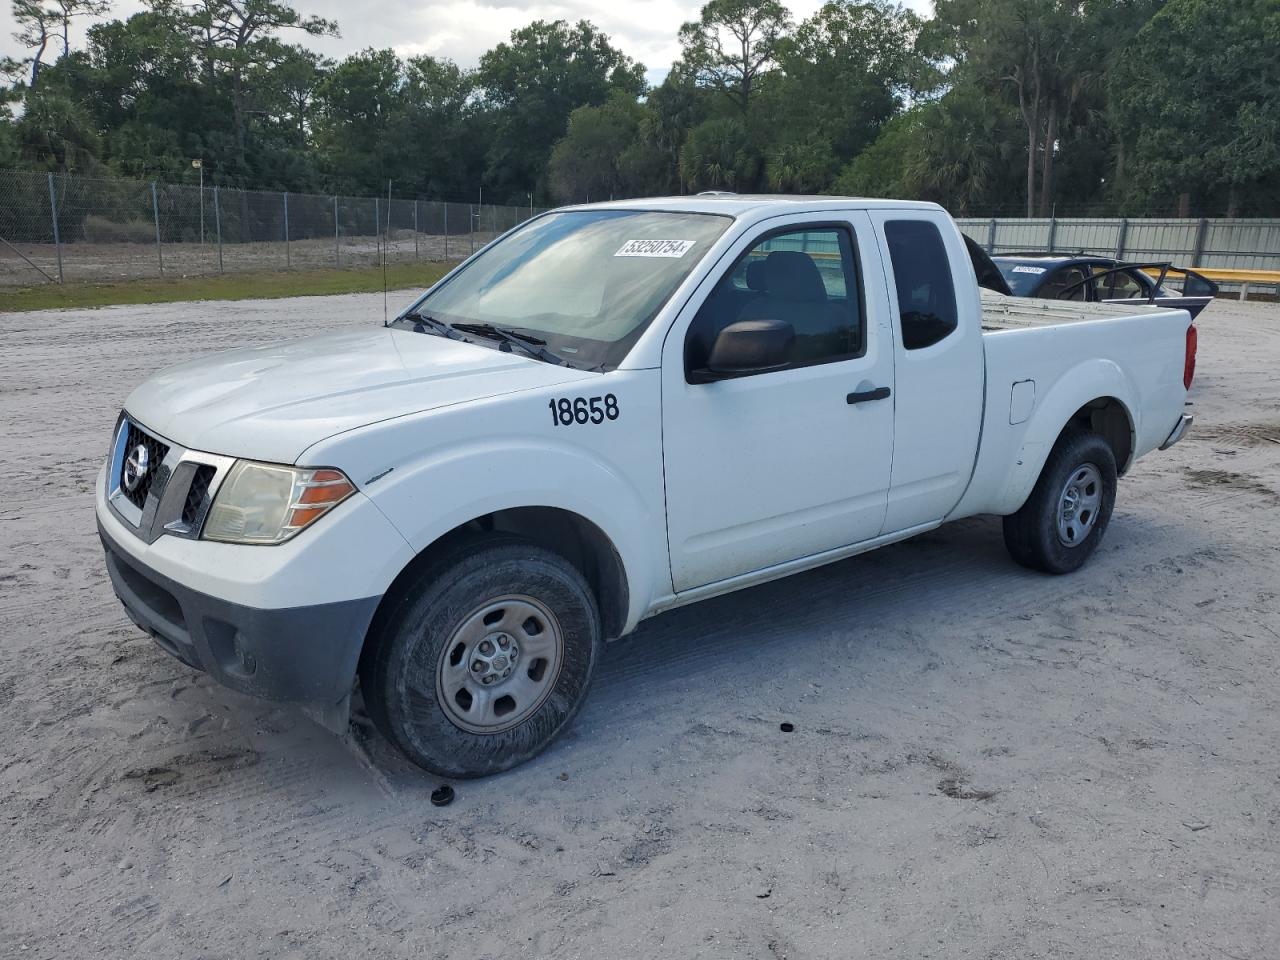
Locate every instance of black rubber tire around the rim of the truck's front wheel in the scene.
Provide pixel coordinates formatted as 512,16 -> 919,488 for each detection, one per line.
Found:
360,535 -> 602,777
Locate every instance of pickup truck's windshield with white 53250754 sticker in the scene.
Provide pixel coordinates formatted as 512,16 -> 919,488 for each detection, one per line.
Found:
394,210 -> 731,369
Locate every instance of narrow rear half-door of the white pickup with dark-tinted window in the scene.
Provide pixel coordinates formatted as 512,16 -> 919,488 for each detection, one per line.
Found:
870,210 -> 986,534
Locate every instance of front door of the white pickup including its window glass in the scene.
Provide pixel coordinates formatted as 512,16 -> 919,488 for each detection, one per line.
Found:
662,214 -> 893,593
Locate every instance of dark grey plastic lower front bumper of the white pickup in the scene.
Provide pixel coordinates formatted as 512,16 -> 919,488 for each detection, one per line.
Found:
97,524 -> 379,708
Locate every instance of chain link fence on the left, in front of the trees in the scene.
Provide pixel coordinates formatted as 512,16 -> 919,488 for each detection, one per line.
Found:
0,170 -> 539,285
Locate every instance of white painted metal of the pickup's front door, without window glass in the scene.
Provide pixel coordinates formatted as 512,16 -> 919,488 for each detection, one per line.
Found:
662,214 -> 893,590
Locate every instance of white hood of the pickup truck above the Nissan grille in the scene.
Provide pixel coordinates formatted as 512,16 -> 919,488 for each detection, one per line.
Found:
124,328 -> 593,463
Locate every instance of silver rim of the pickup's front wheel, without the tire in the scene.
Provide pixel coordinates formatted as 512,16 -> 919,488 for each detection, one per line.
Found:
435,595 -> 564,733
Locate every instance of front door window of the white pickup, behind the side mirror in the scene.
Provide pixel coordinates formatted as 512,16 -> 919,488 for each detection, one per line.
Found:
685,227 -> 864,370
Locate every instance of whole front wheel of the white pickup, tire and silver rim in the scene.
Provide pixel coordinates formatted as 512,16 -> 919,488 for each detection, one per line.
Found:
360,536 -> 600,777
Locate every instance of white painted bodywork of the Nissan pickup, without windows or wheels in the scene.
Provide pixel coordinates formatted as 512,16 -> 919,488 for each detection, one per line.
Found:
99,197 -> 1188,640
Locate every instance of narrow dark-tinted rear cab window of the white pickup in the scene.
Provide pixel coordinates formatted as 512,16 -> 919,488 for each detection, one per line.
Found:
884,220 -> 957,349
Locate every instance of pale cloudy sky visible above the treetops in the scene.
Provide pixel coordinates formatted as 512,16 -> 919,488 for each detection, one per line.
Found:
0,0 -> 932,82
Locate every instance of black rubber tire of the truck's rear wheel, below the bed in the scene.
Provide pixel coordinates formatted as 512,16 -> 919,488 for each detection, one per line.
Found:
1005,429 -> 1117,573
